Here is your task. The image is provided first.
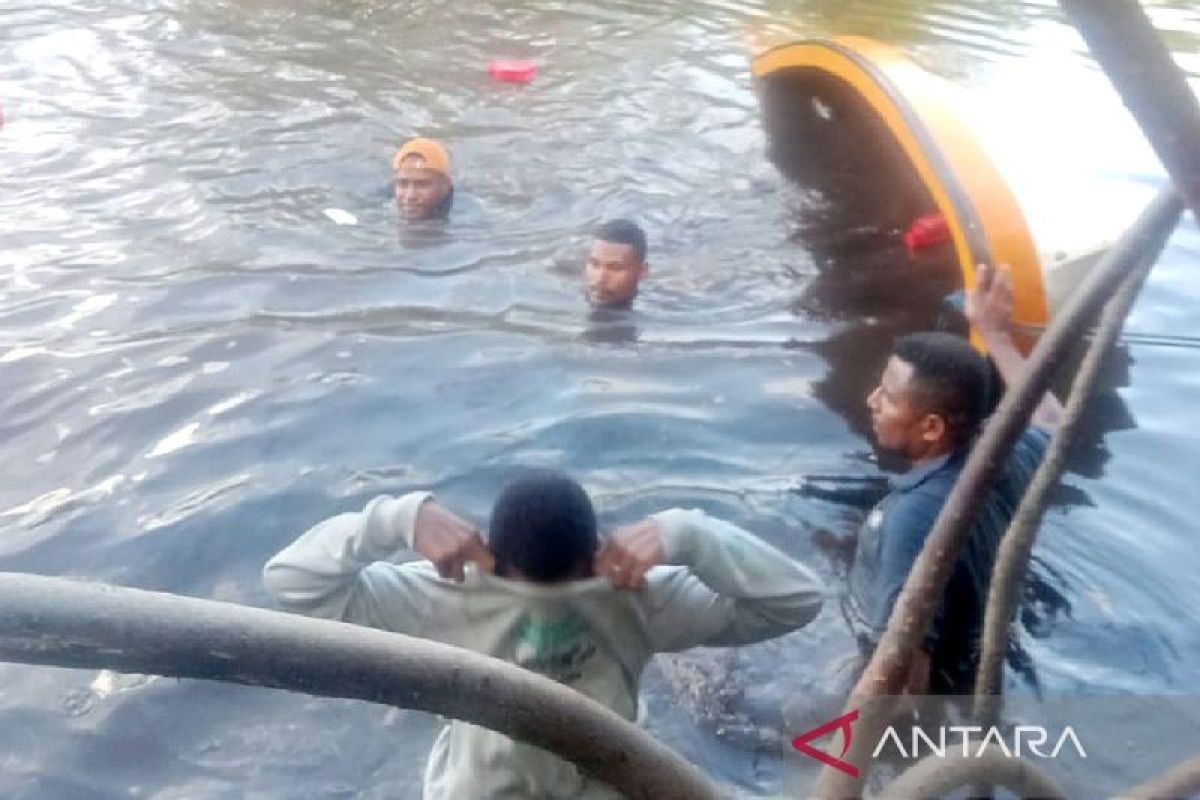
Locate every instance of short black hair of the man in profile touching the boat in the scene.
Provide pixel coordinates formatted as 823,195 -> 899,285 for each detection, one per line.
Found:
892,332 -> 992,446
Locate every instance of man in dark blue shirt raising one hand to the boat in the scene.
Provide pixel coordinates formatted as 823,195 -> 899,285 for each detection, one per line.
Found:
850,265 -> 1062,694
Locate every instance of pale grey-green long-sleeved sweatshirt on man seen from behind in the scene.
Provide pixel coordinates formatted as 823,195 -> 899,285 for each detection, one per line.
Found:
263,492 -> 824,800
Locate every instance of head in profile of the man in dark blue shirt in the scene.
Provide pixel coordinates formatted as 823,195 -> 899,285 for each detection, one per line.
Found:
866,333 -> 991,462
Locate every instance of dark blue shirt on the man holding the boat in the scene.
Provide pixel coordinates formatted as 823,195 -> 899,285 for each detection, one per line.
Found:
850,428 -> 1050,693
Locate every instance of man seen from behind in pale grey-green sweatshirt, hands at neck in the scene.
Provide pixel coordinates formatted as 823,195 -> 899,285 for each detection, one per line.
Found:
263,471 -> 824,800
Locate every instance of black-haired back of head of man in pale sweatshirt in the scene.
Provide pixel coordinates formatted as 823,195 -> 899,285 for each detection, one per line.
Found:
488,470 -> 598,583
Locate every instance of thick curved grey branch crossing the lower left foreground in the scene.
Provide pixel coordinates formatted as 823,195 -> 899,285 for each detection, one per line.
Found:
0,572 -> 719,800
